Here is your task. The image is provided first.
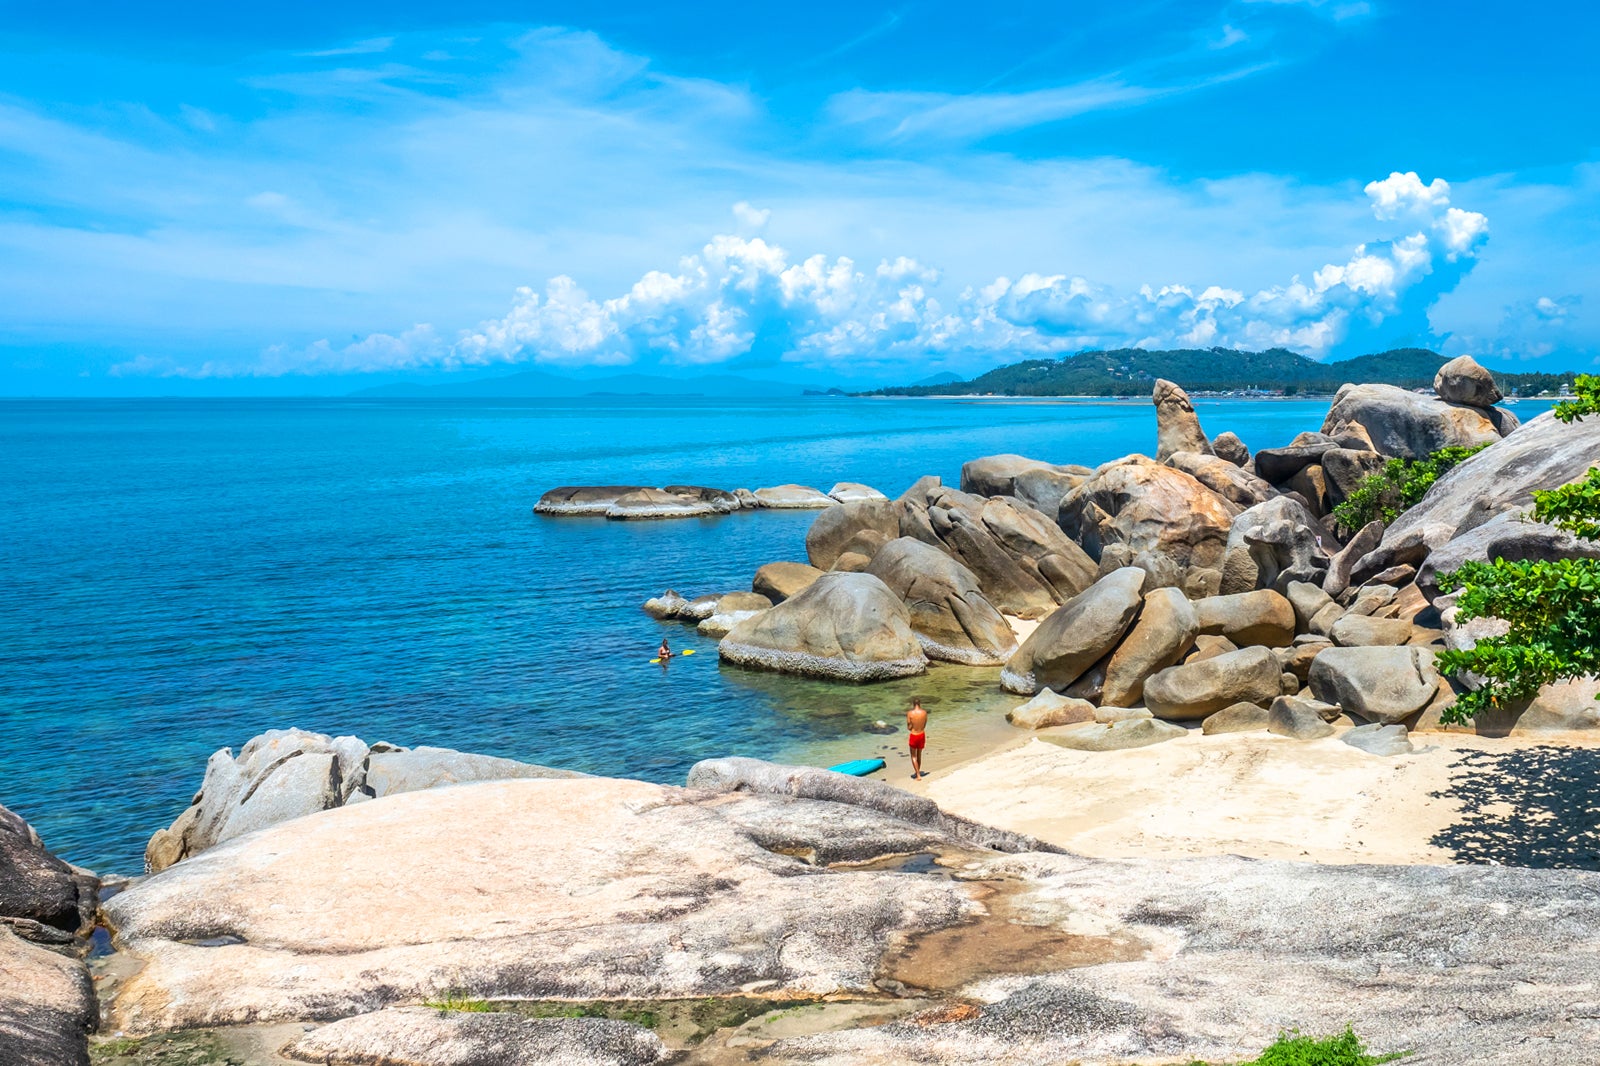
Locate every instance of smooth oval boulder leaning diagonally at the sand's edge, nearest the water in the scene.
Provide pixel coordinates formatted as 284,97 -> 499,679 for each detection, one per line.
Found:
1000,567 -> 1146,696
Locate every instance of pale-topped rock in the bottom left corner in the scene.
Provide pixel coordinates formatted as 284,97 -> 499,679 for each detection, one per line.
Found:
0,924 -> 94,1066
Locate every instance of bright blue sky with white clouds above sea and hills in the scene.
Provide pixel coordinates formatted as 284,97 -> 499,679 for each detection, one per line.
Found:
0,0 -> 1600,394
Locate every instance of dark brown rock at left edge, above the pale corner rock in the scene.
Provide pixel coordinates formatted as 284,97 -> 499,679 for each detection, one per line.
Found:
0,807 -> 98,943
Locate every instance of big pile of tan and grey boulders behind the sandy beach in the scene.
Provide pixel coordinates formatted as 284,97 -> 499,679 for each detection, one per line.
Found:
633,357 -> 1600,736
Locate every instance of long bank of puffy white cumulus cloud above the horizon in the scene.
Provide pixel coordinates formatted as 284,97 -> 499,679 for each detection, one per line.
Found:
190,173 -> 1497,375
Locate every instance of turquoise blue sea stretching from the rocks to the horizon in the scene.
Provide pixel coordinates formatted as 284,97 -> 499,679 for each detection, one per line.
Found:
0,397 -> 1326,872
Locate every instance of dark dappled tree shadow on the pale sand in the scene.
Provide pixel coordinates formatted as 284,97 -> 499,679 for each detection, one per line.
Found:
1432,746 -> 1600,869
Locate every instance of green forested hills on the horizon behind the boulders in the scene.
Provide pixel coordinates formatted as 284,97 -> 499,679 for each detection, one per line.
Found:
870,347 -> 1573,395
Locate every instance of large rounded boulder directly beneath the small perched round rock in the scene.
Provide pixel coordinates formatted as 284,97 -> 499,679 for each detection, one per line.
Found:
1324,384 -> 1501,461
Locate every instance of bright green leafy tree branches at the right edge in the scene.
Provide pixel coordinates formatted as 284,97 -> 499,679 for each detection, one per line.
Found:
1438,375 -> 1600,722
